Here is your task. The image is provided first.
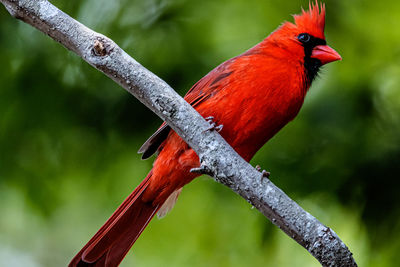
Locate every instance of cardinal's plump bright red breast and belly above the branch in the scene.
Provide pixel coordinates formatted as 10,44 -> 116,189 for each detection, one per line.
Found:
200,66 -> 305,160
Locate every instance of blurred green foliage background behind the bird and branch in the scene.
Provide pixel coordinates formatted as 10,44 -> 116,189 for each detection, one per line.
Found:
0,0 -> 400,267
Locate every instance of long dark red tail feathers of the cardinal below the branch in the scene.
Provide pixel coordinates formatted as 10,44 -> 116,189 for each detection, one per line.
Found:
68,171 -> 159,267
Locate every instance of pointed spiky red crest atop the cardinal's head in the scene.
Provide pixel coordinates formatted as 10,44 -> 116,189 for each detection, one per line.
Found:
293,0 -> 325,39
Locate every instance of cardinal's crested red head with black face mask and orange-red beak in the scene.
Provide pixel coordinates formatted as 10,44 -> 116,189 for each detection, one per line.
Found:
268,1 -> 342,80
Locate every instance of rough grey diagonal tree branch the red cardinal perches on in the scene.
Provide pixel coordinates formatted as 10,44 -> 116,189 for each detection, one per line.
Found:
0,0 -> 357,266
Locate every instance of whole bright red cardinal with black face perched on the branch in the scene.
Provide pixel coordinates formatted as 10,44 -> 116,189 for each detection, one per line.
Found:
69,2 -> 341,267
